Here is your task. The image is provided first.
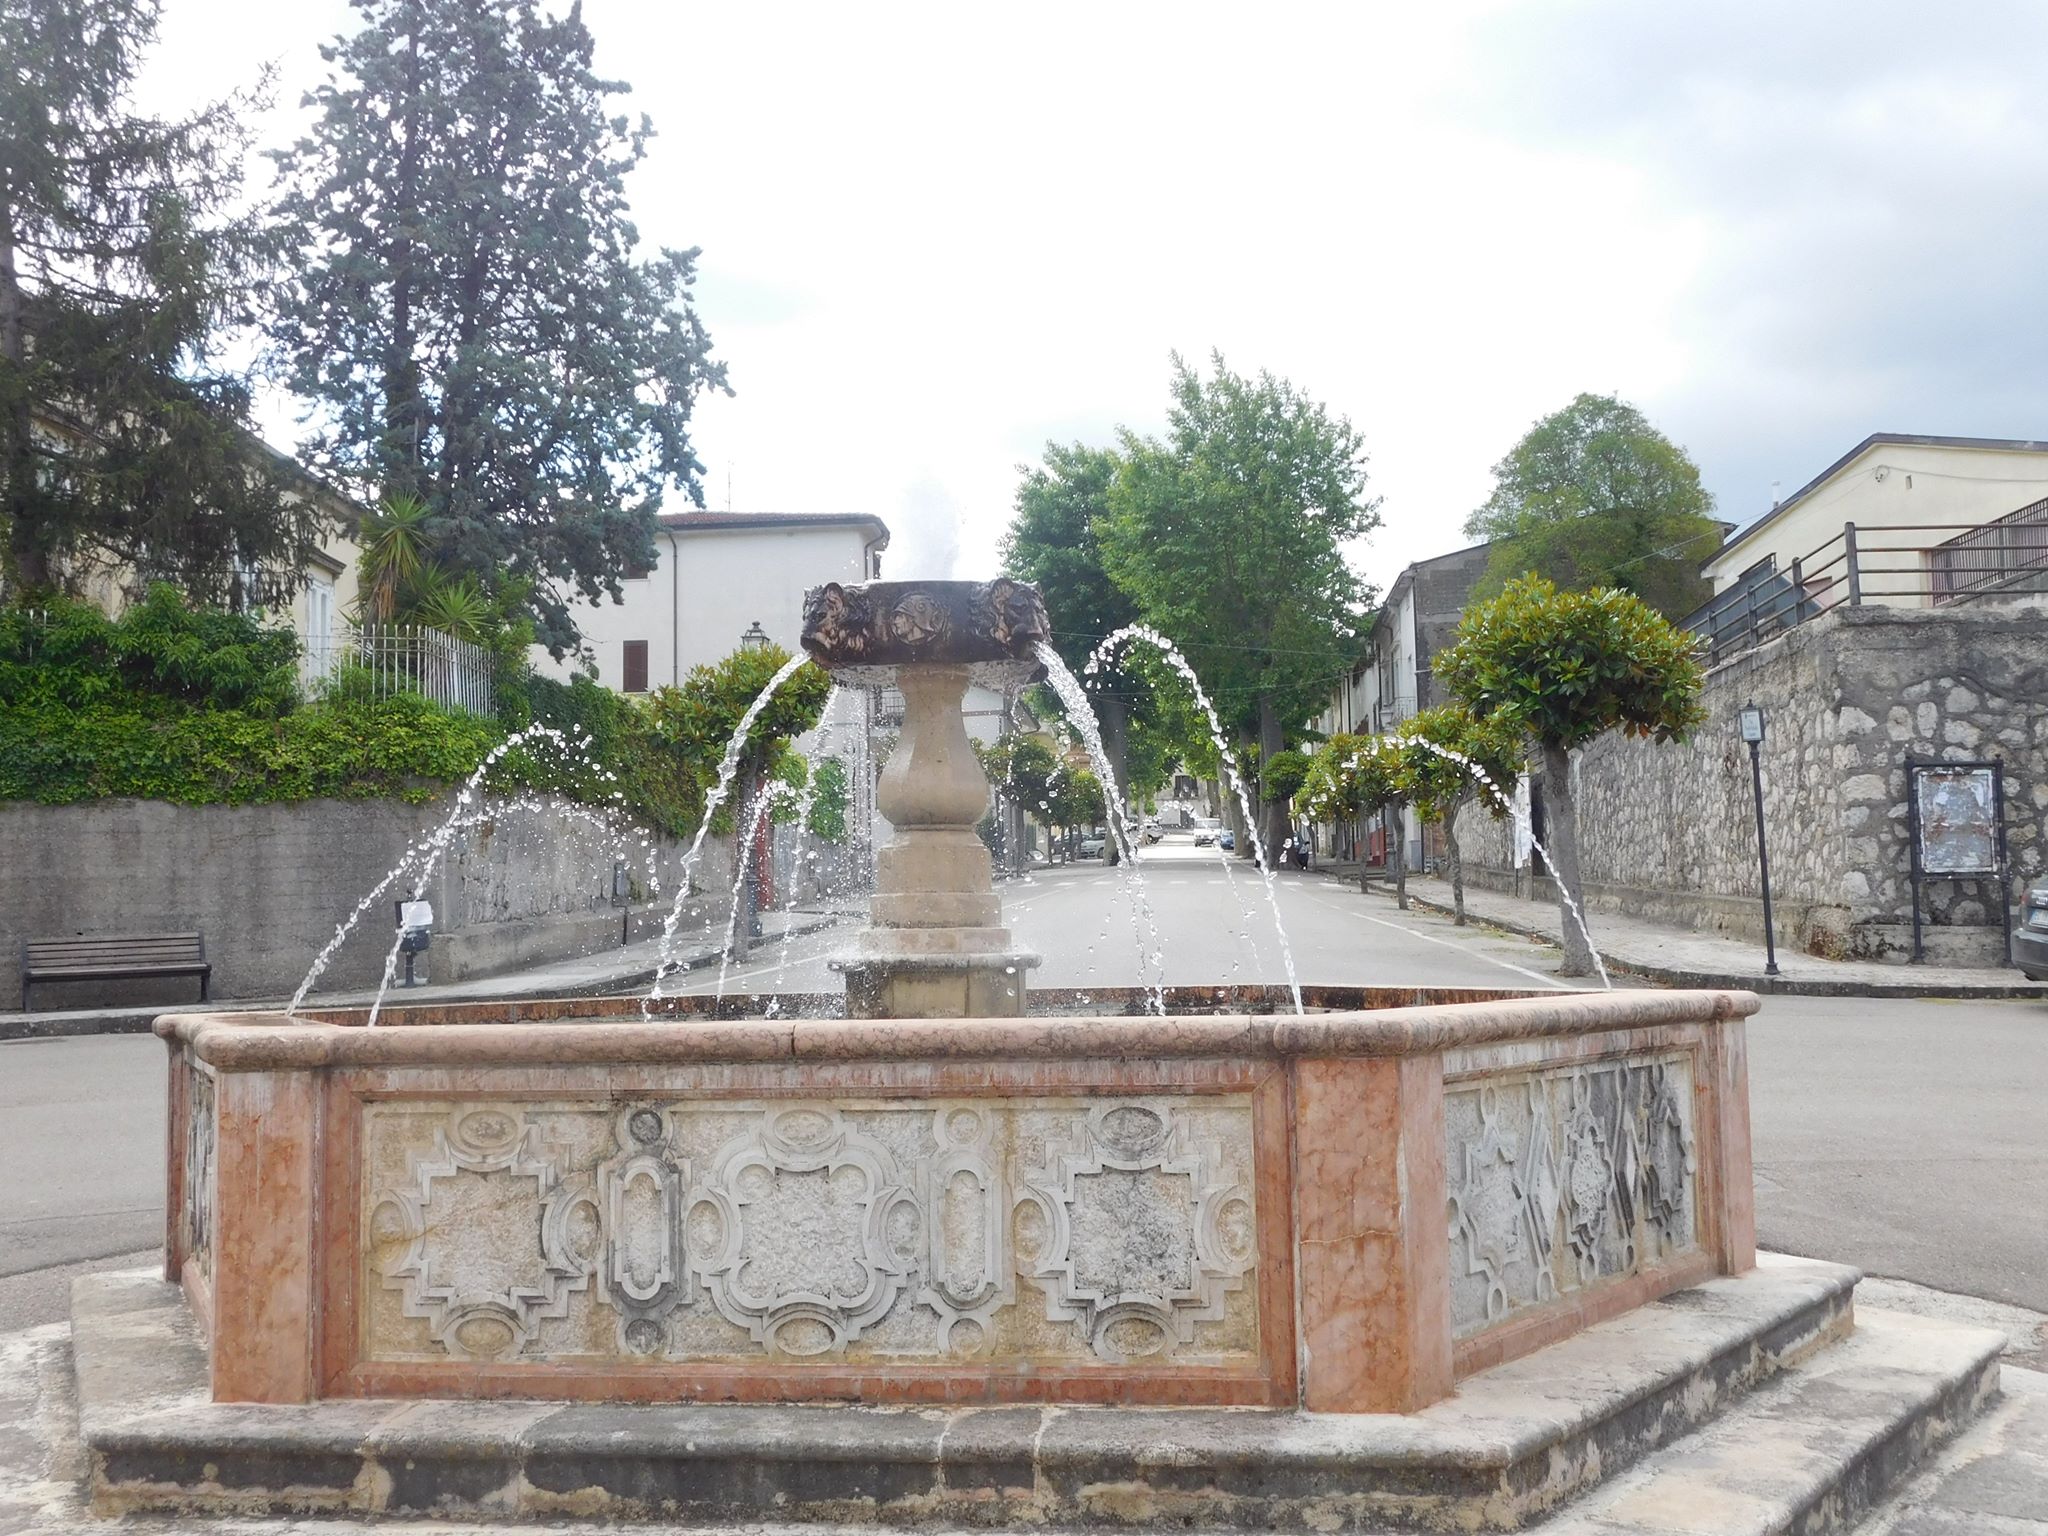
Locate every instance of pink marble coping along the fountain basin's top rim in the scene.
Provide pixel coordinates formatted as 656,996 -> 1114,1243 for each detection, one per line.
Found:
156,989 -> 1759,1073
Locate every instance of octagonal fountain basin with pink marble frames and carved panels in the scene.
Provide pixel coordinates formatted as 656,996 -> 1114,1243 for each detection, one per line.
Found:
156,987 -> 1755,1413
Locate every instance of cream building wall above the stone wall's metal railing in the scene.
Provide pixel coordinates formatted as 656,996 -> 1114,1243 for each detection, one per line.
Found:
1704,442 -> 2048,608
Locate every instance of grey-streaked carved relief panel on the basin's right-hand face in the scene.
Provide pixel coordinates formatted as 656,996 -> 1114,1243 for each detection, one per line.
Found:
1444,1053 -> 1700,1337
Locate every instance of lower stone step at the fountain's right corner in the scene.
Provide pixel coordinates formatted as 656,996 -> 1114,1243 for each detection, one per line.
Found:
1536,1309 -> 2005,1536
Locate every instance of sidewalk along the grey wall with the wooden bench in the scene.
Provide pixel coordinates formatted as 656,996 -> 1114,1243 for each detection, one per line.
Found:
0,907 -> 846,1040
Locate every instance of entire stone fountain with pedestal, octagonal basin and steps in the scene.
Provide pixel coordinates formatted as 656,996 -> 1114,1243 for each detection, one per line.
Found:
74,582 -> 2001,1530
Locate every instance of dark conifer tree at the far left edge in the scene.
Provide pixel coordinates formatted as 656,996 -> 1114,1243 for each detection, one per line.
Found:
0,0 -> 319,606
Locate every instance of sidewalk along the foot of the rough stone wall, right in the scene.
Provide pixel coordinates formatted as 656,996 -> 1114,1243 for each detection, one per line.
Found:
1319,864 -> 2048,999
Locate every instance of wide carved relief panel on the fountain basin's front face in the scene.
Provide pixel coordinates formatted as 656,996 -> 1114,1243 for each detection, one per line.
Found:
360,1094 -> 1260,1366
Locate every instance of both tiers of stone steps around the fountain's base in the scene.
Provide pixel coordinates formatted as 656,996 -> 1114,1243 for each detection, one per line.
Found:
72,1260 -> 2001,1536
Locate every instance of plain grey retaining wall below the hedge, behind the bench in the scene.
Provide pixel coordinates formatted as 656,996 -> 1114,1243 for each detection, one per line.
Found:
0,797 -> 733,1010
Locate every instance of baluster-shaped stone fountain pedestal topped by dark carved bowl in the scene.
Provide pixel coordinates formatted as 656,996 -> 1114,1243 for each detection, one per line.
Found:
803,582 -> 1051,1018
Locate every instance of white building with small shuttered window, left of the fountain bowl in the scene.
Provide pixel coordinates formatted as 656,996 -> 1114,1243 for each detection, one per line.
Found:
532,512 -> 889,692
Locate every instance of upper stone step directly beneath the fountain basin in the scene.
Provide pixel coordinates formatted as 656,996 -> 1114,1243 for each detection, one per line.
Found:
74,1260 -> 1875,1528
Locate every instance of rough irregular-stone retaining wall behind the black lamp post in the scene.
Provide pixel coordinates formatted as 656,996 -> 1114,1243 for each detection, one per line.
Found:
1458,604 -> 2048,965
